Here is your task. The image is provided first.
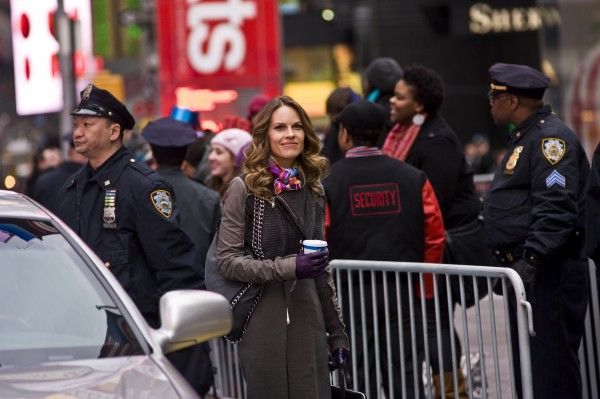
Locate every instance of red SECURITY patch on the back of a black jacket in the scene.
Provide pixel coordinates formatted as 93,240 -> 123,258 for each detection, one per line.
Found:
349,183 -> 400,216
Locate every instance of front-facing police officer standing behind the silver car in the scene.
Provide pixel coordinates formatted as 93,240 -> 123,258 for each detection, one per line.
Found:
57,84 -> 203,327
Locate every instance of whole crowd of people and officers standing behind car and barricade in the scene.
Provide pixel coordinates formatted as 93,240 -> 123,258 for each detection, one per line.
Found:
21,57 -> 600,398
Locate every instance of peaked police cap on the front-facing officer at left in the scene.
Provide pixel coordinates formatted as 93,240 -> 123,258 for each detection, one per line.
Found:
71,84 -> 135,130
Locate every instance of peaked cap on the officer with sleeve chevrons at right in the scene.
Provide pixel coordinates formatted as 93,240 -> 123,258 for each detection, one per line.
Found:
489,63 -> 550,100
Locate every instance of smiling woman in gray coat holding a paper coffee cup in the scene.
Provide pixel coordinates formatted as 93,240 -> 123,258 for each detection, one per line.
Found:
217,96 -> 348,399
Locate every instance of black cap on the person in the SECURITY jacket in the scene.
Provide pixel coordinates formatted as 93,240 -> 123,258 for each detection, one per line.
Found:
336,100 -> 387,132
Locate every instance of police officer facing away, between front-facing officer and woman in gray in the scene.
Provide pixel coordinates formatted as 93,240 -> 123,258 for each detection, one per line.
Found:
142,118 -> 220,396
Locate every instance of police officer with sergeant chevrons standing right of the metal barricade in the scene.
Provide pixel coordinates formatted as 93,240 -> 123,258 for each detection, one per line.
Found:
484,64 -> 589,398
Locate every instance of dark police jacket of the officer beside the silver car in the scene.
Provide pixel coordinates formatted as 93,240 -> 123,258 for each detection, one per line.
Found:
58,147 -> 203,317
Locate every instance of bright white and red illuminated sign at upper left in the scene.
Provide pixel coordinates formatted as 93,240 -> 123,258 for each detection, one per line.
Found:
10,0 -> 93,115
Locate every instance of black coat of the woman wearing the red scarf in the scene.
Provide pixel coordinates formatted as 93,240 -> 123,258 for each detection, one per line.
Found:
406,112 -> 481,230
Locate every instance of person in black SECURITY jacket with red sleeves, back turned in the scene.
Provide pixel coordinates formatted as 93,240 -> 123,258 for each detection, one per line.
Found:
323,100 -> 445,398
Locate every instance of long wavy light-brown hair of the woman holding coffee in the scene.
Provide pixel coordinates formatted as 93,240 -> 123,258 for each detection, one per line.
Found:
243,96 -> 327,199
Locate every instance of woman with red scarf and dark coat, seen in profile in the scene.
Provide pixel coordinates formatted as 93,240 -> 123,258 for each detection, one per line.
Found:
383,65 -> 488,397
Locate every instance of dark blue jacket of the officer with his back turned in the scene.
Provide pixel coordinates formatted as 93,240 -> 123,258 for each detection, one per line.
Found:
156,166 -> 221,275
